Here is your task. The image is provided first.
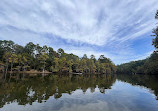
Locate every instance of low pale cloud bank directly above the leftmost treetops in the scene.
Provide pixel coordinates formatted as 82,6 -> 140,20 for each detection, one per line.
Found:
0,27 -> 50,45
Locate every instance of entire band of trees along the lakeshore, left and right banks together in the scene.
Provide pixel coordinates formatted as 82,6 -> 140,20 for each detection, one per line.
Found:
0,11 -> 158,78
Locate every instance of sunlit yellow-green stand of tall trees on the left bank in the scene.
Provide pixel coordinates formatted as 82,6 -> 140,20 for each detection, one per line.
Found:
0,40 -> 116,74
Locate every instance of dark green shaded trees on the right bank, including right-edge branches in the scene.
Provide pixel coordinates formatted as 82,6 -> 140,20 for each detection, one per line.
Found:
117,11 -> 158,75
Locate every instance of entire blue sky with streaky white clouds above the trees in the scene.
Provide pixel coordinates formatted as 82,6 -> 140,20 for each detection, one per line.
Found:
0,0 -> 158,64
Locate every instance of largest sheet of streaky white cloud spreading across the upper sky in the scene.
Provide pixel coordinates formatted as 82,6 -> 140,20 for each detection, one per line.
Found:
0,0 -> 158,45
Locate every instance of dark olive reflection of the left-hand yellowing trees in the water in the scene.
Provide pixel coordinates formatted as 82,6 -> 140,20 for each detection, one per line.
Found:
0,74 -> 116,107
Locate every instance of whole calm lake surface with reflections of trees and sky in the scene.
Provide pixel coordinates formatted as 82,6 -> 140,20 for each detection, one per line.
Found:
0,75 -> 158,111
